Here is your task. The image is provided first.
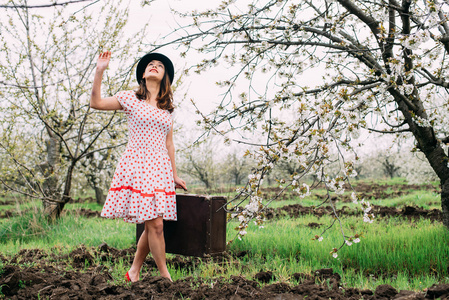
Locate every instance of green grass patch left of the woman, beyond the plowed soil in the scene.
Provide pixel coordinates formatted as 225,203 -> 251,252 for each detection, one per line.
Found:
0,207 -> 135,255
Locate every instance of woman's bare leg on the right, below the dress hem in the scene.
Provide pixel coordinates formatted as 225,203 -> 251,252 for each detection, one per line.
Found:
145,217 -> 171,280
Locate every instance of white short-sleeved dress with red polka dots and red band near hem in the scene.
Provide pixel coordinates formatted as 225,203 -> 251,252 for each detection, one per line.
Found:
101,91 -> 177,223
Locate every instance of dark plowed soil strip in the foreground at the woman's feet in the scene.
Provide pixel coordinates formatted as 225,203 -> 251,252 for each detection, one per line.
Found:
0,244 -> 449,300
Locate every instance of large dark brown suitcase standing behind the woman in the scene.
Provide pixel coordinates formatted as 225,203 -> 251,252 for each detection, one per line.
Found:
136,194 -> 226,256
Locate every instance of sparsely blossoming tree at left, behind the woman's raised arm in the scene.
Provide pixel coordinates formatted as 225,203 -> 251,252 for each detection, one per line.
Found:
0,1 -> 145,218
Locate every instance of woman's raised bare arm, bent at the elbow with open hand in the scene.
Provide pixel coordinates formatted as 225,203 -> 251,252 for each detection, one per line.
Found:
90,51 -> 122,110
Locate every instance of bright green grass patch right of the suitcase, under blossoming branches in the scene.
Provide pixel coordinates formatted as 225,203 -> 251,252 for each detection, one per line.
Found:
230,216 -> 449,284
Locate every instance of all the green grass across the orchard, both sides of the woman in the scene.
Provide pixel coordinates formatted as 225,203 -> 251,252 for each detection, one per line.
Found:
0,180 -> 449,291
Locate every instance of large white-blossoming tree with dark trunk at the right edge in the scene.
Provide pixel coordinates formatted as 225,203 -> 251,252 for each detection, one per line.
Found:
155,0 -> 449,256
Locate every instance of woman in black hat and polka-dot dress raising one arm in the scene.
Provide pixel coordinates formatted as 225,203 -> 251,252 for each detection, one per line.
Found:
90,51 -> 187,282
